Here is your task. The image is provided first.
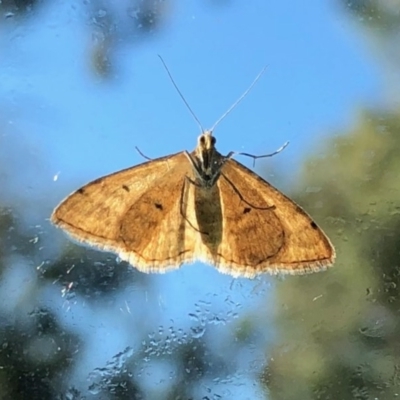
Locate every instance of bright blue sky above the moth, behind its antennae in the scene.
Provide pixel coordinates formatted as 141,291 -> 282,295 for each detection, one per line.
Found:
2,0 -> 380,184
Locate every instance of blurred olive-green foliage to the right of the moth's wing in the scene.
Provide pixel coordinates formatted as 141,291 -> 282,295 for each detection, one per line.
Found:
263,111 -> 400,400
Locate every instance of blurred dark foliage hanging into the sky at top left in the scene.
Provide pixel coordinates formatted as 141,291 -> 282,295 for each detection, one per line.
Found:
0,0 -> 171,79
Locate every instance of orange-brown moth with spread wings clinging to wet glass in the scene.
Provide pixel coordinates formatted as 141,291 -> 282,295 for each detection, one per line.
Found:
51,62 -> 335,278
